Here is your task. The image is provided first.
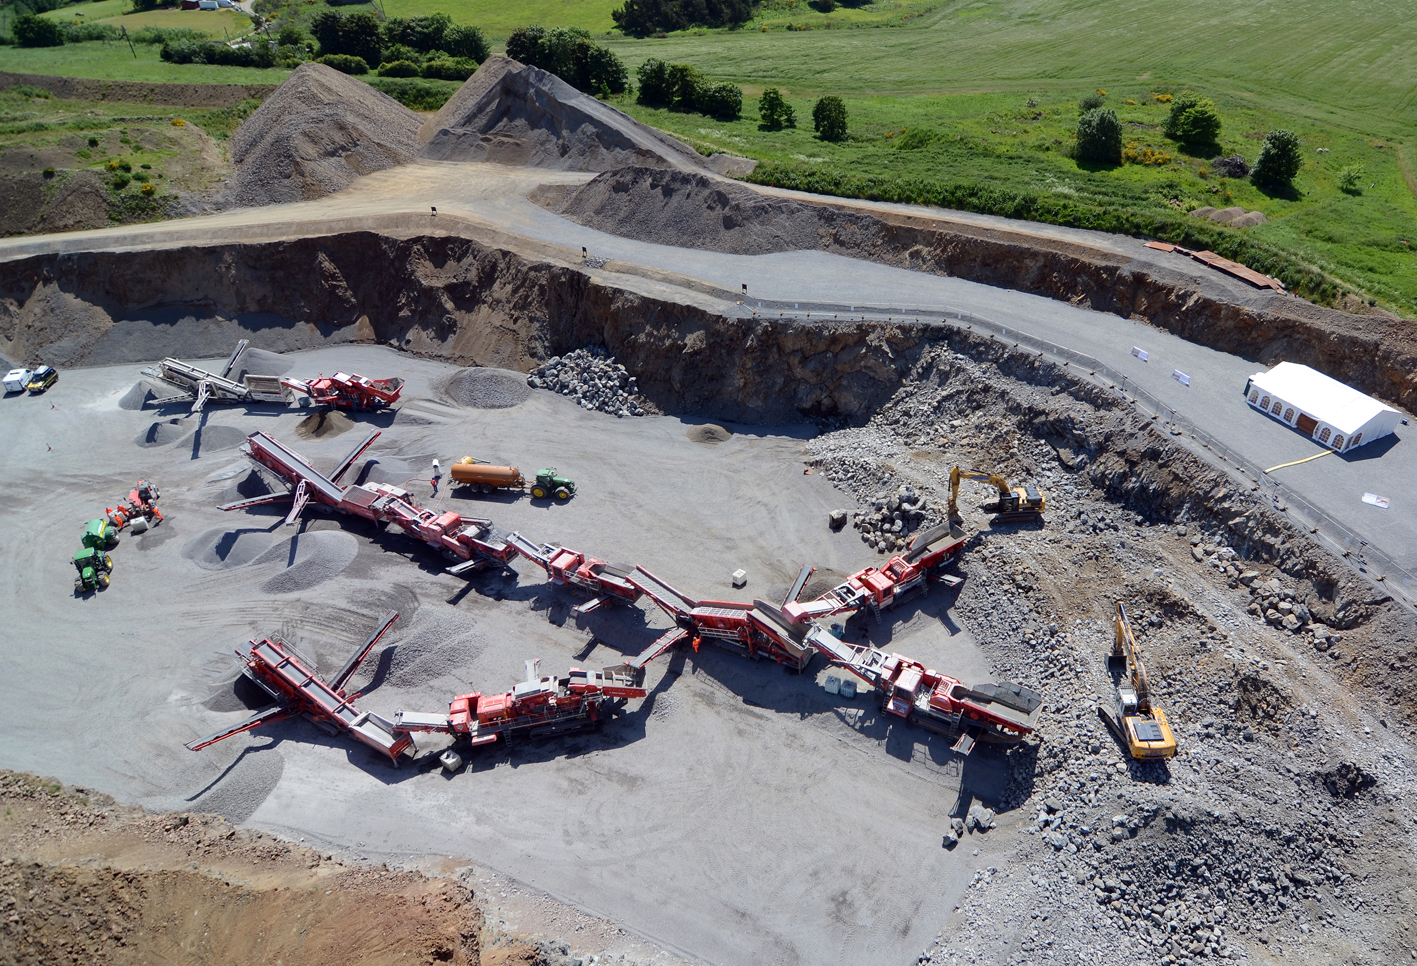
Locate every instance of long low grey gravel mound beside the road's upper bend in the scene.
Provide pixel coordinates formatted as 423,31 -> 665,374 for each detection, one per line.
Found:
531,167 -> 883,255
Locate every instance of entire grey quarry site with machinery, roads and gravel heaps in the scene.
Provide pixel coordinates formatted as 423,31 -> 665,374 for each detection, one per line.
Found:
0,57 -> 1417,966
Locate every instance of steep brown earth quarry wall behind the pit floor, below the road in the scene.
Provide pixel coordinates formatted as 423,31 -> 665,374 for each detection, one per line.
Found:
0,231 -> 939,424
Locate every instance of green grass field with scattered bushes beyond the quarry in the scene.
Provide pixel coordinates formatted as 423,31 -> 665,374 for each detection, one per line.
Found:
0,0 -> 1417,314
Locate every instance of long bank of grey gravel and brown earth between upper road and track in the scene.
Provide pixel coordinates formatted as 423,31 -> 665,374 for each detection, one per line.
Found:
546,169 -> 1417,408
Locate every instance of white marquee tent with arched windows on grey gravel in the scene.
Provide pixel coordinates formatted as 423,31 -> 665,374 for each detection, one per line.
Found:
1244,363 -> 1401,453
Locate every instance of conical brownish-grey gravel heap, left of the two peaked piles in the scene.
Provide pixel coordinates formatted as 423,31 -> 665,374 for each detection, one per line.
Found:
221,64 -> 422,208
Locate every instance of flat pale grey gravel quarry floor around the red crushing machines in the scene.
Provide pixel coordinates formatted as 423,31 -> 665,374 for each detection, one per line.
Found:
0,347 -> 1006,963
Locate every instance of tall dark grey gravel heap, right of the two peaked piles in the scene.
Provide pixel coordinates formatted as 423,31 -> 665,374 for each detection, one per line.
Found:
419,57 -> 703,171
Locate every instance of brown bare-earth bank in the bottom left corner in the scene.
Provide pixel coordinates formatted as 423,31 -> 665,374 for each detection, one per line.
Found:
0,772 -> 487,966
